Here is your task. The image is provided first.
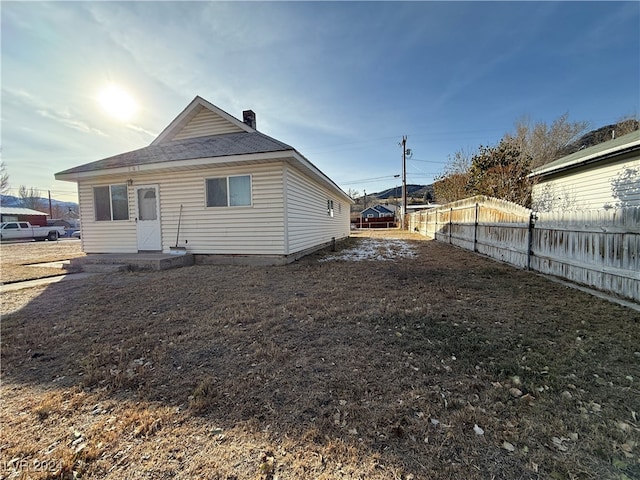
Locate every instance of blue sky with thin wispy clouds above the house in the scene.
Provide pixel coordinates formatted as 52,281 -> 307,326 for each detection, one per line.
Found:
0,1 -> 640,201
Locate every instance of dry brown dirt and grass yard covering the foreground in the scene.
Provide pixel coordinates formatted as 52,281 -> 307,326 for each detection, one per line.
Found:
0,231 -> 640,480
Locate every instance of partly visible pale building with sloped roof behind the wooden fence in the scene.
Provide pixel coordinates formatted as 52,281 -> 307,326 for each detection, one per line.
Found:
529,130 -> 640,212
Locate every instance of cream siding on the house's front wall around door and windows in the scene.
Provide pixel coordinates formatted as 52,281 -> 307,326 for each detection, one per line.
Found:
79,162 -> 285,255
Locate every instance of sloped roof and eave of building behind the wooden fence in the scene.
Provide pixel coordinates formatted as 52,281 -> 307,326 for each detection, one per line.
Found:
529,130 -> 640,177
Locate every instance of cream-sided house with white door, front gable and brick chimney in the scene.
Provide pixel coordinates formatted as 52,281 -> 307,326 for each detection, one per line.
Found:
55,97 -> 353,264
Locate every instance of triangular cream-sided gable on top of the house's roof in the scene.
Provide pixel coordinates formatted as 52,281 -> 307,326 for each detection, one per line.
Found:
151,96 -> 256,145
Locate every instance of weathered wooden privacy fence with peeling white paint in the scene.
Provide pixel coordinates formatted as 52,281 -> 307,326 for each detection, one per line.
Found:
407,196 -> 640,303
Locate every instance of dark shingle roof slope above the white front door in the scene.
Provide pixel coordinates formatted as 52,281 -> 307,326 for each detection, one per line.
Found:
59,132 -> 293,175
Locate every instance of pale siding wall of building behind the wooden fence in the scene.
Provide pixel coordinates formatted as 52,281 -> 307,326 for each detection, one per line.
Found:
532,159 -> 640,211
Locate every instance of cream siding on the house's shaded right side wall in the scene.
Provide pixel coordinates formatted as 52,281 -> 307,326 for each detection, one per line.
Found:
285,166 -> 349,254
